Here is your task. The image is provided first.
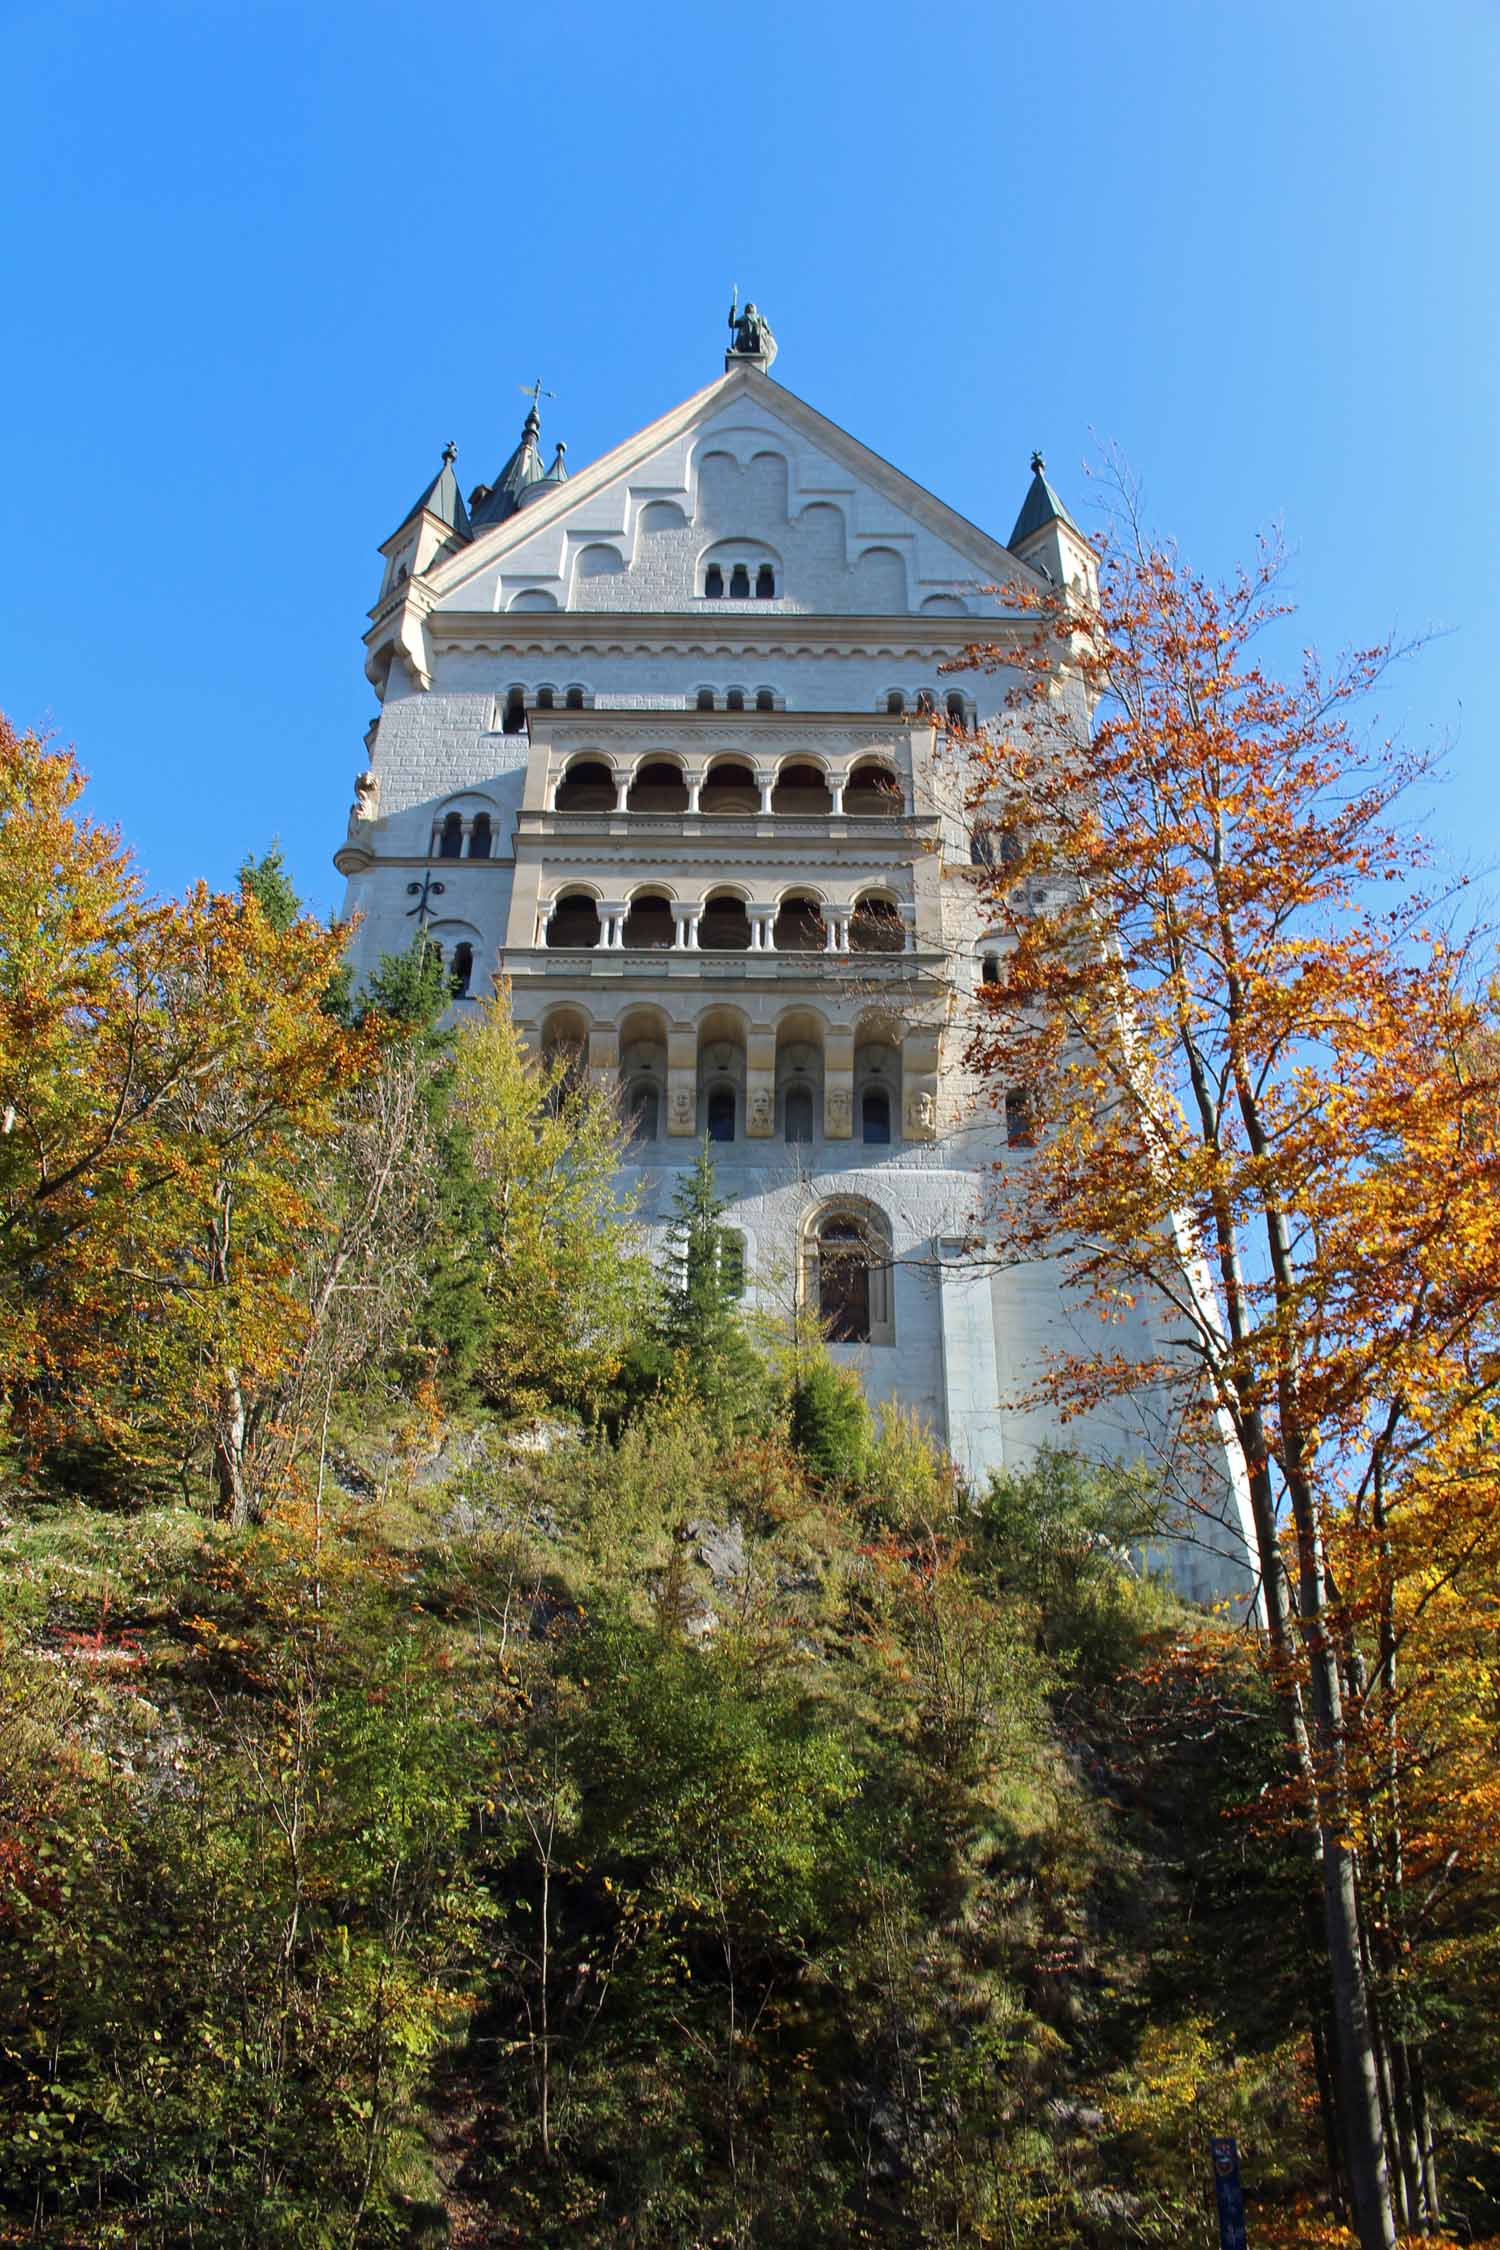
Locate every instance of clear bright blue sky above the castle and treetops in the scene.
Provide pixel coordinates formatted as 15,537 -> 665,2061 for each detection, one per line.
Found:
0,0 -> 1500,907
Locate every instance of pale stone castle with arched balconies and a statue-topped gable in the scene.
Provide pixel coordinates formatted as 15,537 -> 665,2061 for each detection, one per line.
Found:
337,306 -> 1244,1595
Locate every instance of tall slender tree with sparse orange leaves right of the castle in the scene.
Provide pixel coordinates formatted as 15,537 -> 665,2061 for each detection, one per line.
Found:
969,509 -> 1500,2250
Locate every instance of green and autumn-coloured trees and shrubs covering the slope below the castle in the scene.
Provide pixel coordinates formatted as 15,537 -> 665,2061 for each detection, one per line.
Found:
0,715 -> 1500,2250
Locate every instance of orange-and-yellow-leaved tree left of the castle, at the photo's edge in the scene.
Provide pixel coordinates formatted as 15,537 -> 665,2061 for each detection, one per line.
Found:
0,722 -> 378,1521
